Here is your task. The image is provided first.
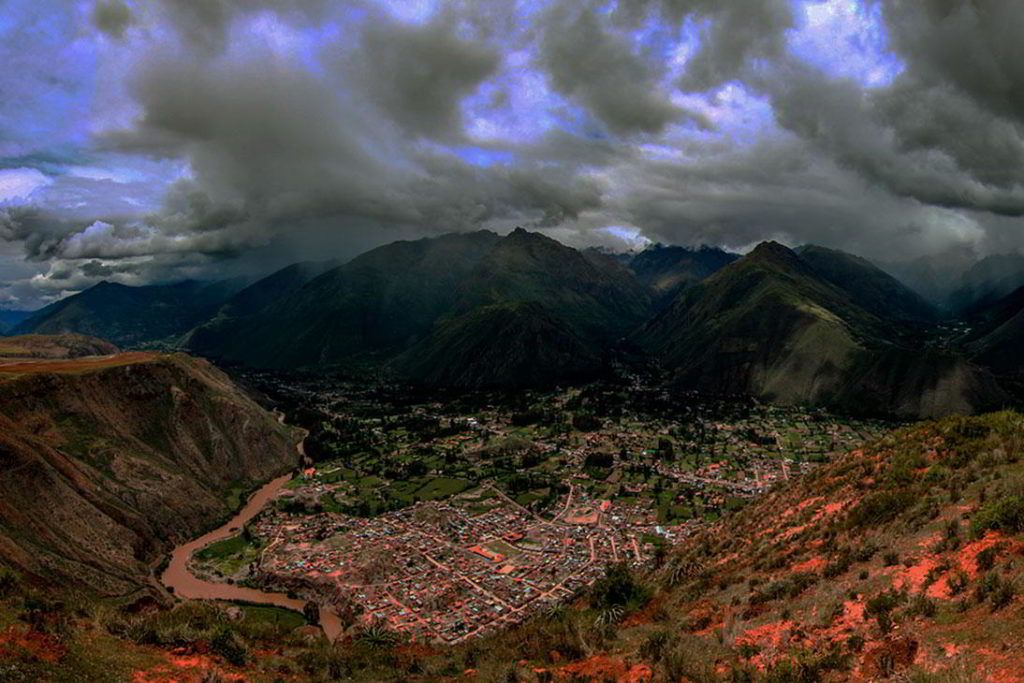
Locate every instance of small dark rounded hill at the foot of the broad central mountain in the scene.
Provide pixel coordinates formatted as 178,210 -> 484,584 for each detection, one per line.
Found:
390,302 -> 601,389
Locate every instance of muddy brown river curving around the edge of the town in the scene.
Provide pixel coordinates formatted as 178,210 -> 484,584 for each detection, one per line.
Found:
160,464 -> 342,641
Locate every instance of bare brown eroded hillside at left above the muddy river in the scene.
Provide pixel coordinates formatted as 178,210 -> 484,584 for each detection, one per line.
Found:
0,340 -> 296,594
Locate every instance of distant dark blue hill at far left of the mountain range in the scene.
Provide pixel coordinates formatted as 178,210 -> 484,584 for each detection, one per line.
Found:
10,281 -> 242,347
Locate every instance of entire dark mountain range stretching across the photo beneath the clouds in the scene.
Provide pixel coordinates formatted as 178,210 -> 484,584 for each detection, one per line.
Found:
8,228 -> 1024,416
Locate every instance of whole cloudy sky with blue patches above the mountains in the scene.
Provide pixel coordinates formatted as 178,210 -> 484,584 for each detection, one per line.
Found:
0,0 -> 1024,309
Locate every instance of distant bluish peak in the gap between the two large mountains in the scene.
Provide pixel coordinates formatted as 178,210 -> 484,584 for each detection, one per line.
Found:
629,244 -> 739,305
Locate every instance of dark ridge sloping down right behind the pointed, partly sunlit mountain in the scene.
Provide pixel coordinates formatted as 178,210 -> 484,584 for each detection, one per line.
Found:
797,245 -> 939,323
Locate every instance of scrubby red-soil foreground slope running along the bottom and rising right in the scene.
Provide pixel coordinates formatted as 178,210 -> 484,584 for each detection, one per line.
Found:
6,413 -> 1024,683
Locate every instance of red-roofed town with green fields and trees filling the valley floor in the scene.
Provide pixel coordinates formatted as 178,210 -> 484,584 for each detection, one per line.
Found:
193,371 -> 892,644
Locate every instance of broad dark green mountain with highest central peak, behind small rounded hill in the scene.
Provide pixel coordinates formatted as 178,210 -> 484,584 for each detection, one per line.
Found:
187,229 -> 650,377
